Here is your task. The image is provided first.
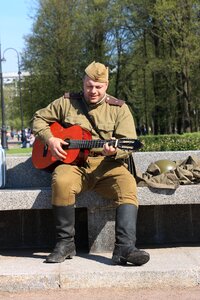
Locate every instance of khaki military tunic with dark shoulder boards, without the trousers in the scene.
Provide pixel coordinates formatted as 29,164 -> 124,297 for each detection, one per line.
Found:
33,94 -> 136,159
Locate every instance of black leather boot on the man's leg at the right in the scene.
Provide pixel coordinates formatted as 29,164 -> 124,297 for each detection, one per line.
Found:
112,204 -> 150,266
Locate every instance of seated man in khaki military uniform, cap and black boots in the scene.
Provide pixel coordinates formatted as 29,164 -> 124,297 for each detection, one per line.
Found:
33,62 -> 149,265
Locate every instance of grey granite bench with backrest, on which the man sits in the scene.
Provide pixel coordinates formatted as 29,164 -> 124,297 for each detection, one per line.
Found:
0,151 -> 200,252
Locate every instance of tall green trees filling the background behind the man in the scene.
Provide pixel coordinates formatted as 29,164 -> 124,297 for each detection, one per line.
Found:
3,0 -> 200,135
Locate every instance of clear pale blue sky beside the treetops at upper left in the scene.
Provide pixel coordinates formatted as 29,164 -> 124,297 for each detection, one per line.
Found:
0,0 -> 34,73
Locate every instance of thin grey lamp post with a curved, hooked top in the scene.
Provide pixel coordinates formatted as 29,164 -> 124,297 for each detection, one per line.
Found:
1,47 -> 26,146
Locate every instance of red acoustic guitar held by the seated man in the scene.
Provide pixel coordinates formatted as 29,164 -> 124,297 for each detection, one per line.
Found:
32,122 -> 143,170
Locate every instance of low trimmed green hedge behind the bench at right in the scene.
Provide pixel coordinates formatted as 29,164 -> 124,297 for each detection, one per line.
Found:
139,132 -> 200,152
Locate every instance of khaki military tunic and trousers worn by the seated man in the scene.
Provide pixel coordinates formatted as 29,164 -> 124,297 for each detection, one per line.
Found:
33,94 -> 138,206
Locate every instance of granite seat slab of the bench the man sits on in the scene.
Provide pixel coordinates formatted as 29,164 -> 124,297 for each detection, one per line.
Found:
0,185 -> 200,212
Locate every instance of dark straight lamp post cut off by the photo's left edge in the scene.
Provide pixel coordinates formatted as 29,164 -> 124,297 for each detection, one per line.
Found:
0,44 -> 8,149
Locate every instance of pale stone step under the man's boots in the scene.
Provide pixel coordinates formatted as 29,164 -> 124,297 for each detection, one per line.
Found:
0,247 -> 200,292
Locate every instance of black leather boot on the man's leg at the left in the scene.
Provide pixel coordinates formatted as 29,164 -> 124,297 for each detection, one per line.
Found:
46,205 -> 76,263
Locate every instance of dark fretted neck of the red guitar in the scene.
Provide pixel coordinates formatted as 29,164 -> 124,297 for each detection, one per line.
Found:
64,139 -> 118,149
